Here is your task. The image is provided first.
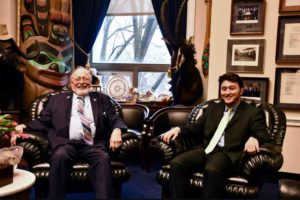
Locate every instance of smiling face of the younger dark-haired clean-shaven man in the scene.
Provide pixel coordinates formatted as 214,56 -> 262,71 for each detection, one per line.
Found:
220,80 -> 243,107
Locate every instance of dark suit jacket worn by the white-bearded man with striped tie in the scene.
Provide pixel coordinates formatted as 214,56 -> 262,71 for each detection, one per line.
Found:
27,92 -> 127,150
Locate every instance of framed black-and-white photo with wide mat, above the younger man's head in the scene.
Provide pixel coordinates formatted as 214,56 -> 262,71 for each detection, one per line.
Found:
226,39 -> 265,73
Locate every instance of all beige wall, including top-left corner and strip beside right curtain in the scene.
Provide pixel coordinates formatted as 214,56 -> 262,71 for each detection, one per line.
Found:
0,0 -> 300,174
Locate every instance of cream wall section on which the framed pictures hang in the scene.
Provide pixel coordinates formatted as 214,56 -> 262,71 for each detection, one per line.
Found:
207,0 -> 300,174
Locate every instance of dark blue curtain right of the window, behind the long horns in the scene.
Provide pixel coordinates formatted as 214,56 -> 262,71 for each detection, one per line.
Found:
152,0 -> 187,55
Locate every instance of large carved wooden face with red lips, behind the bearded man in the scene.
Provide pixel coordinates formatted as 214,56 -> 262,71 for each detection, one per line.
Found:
21,36 -> 73,88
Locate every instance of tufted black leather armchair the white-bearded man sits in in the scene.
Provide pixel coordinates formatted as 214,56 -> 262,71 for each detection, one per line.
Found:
18,90 -> 140,198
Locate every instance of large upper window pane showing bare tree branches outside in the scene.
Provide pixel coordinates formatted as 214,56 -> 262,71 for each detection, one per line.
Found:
92,15 -> 170,64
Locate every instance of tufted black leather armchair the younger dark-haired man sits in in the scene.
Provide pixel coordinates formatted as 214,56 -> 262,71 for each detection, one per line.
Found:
152,99 -> 286,198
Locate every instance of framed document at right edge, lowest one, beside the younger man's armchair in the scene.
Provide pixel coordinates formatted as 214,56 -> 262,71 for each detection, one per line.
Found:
274,68 -> 300,109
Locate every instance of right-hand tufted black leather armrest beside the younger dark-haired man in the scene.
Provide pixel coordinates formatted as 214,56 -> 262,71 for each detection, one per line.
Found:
240,143 -> 283,179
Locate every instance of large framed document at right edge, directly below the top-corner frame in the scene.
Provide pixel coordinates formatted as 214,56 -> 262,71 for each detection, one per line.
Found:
276,15 -> 300,63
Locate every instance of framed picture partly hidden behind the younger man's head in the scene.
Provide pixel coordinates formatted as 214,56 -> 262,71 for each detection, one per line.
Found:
242,77 -> 269,102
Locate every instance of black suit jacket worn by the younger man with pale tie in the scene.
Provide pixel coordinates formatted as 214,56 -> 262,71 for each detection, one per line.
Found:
180,101 -> 269,163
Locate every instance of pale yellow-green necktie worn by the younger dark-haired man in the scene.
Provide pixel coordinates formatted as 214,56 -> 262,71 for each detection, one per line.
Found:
205,108 -> 232,154
